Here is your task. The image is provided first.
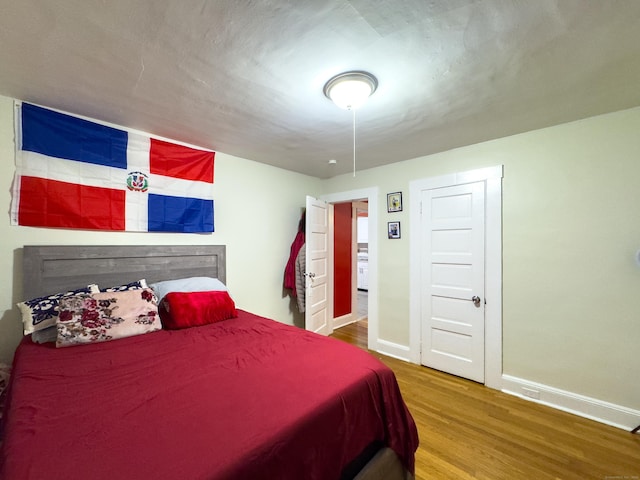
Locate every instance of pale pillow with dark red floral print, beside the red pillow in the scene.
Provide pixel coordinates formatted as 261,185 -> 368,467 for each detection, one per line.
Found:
56,288 -> 162,347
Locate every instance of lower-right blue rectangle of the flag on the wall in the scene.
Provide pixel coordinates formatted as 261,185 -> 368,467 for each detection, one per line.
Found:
148,194 -> 214,233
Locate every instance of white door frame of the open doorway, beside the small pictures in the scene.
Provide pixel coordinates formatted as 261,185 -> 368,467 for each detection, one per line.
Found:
318,187 -> 378,351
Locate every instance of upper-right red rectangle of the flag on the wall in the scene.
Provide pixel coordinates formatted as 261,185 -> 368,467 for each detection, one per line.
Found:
149,138 -> 214,183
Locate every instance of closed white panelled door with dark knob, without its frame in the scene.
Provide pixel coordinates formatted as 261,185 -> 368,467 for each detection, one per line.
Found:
420,182 -> 485,383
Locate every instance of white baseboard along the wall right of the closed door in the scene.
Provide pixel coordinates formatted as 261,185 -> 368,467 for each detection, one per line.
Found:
502,375 -> 640,431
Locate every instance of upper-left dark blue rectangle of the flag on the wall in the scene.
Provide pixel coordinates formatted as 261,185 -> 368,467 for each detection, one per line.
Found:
22,103 -> 127,169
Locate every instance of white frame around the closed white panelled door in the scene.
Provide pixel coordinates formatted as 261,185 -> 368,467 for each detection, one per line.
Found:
409,165 -> 503,390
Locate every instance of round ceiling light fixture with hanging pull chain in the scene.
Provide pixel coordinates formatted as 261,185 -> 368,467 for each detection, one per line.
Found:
323,71 -> 378,177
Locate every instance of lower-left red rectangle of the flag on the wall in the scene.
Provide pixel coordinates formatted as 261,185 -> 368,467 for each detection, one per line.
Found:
18,177 -> 126,230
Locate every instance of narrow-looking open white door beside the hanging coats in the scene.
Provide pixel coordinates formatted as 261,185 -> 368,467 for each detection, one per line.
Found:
305,196 -> 333,335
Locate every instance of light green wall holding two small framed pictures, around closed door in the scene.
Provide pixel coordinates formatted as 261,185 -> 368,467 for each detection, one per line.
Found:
323,108 -> 640,409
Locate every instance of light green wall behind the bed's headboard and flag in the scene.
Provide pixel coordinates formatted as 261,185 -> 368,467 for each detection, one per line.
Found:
0,97 -> 321,362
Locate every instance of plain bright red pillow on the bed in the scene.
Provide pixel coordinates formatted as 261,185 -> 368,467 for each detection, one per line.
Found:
158,291 -> 238,330
